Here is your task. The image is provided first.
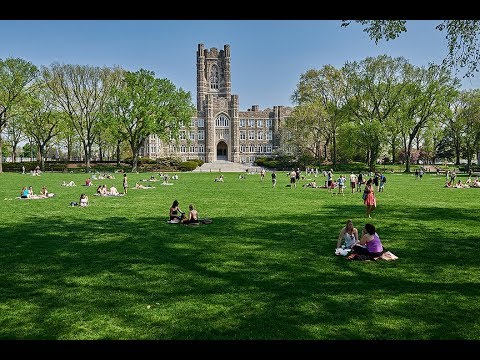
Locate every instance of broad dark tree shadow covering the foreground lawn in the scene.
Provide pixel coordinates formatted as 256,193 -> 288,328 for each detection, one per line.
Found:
0,210 -> 480,339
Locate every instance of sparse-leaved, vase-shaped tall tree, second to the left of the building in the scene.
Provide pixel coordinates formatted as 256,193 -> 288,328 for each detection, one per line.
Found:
41,63 -> 122,171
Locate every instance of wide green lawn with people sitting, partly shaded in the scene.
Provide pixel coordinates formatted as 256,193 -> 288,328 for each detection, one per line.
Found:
0,172 -> 480,340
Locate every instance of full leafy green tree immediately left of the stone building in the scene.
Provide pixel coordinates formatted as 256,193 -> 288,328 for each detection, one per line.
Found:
106,69 -> 195,171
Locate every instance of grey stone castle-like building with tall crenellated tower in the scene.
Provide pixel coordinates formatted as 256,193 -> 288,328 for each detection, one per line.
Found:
141,44 -> 292,163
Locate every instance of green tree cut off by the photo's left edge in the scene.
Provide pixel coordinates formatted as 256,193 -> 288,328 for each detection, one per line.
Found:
0,58 -> 38,173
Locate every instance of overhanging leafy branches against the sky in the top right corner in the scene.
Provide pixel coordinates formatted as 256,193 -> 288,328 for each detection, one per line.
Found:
341,20 -> 480,77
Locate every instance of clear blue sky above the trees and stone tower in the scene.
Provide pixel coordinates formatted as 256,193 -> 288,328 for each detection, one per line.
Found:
0,20 -> 480,110
